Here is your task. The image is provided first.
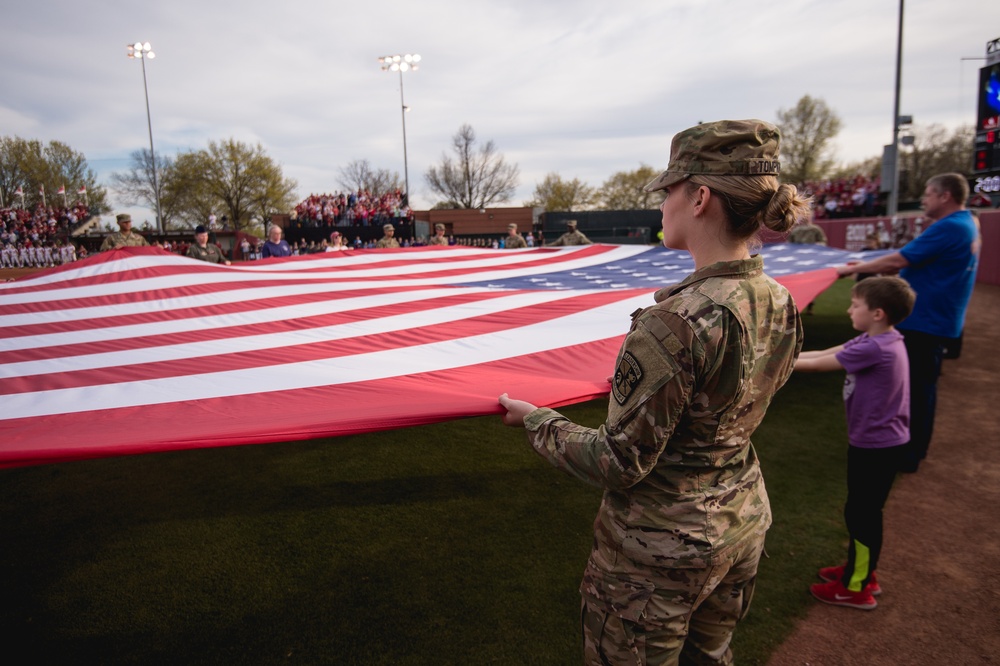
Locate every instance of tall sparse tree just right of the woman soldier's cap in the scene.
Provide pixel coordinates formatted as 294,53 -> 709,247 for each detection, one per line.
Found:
777,95 -> 841,183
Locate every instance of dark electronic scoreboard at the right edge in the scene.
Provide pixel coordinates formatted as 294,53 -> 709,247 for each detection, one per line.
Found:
972,38 -> 1000,194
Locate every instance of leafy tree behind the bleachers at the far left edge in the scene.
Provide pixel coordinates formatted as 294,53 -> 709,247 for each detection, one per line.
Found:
0,136 -> 108,213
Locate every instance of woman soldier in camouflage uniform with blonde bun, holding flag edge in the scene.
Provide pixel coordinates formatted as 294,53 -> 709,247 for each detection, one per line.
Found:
500,120 -> 809,664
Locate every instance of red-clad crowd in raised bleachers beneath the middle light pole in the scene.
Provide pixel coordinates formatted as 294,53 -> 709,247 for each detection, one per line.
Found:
291,190 -> 413,228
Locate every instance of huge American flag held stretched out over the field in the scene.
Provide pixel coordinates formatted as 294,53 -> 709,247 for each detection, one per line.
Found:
0,245 -> 856,467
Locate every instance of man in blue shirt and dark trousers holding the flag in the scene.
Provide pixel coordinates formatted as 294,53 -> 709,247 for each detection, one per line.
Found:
837,173 -> 981,472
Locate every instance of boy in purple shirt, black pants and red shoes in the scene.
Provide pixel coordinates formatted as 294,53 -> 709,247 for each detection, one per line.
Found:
795,277 -> 916,610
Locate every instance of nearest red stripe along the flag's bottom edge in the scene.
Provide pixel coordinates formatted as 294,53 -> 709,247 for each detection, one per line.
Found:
0,335 -> 624,467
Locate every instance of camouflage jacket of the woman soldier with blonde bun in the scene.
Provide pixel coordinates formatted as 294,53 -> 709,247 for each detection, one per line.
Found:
524,256 -> 802,573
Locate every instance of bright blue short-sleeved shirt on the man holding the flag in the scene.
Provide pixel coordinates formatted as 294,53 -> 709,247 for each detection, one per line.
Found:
899,210 -> 979,338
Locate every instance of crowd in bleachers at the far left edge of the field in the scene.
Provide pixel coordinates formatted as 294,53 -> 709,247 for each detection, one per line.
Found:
0,201 -> 90,268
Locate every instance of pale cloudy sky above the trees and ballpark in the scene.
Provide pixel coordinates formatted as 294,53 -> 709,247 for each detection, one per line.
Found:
0,0 -> 1000,219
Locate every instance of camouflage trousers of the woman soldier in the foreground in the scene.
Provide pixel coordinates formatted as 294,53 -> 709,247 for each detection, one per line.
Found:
581,537 -> 764,666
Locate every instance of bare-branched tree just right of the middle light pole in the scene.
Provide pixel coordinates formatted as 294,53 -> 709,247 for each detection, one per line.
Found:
424,125 -> 519,208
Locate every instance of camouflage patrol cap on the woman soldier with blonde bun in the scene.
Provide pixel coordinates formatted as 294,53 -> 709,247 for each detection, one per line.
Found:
645,120 -> 781,192
